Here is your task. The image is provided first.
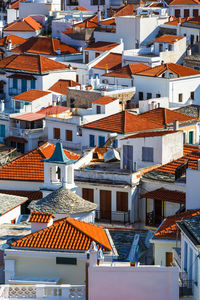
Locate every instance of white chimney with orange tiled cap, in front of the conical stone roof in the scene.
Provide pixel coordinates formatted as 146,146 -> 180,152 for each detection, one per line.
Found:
29,212 -> 55,233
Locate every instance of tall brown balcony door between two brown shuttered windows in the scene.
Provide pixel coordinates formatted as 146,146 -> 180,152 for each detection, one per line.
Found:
100,190 -> 111,220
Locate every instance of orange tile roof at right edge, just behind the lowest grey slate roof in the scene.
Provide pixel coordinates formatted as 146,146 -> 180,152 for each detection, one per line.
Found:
153,209 -> 200,240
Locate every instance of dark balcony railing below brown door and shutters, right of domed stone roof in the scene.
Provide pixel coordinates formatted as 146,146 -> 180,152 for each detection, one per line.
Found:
95,210 -> 130,224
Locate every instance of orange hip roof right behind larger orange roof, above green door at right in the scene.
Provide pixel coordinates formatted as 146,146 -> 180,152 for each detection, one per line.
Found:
140,107 -> 197,125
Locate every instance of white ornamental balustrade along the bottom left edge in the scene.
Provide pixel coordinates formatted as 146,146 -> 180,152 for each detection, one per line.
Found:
0,284 -> 85,300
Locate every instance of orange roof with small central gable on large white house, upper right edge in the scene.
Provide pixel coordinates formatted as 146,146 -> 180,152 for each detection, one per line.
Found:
137,63 -> 200,77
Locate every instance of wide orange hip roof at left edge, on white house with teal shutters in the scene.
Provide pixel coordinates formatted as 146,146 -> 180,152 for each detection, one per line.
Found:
0,54 -> 68,74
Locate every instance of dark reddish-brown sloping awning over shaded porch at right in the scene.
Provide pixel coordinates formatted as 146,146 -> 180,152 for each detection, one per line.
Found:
140,188 -> 185,204
